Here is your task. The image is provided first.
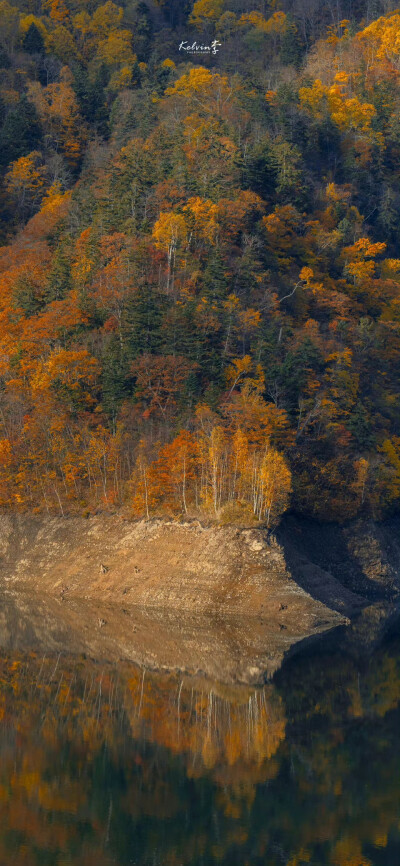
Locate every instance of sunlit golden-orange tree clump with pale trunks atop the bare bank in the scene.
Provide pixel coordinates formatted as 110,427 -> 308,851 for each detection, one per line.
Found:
131,384 -> 291,525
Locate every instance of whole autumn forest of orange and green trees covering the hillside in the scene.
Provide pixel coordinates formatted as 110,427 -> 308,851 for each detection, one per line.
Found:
0,0 -> 400,527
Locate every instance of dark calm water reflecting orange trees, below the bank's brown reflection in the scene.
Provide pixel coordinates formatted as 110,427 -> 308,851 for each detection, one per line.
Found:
0,642 -> 400,866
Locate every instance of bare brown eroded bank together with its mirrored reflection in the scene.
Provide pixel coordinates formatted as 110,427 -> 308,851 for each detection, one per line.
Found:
0,515 -> 398,682
